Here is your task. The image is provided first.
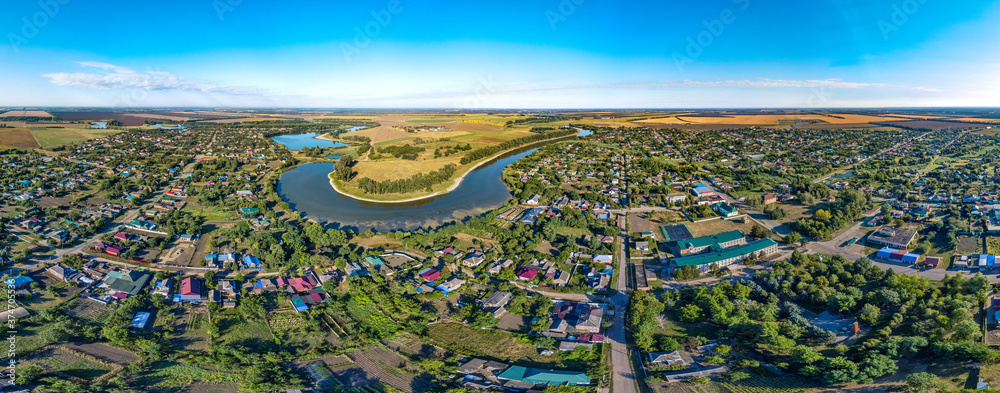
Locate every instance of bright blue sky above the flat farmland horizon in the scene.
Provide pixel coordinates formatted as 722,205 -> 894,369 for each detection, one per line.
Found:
0,0 -> 1000,109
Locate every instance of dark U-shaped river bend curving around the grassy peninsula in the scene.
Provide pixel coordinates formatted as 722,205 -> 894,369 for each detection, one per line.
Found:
278,126 -> 591,232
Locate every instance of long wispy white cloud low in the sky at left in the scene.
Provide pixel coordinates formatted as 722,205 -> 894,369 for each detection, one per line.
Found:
42,61 -> 268,95
